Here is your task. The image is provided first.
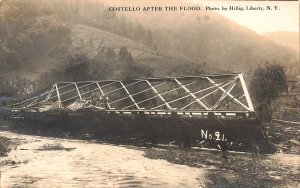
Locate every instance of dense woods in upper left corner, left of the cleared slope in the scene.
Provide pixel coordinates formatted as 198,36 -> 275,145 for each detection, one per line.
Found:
0,0 -> 70,70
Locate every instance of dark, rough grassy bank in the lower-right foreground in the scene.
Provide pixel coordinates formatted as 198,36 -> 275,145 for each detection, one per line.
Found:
145,149 -> 300,187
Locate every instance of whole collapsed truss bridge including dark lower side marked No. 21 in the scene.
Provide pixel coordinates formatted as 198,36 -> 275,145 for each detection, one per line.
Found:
9,74 -> 262,150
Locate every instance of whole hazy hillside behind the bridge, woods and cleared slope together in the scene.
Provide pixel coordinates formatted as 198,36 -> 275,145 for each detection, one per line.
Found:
0,0 -> 299,94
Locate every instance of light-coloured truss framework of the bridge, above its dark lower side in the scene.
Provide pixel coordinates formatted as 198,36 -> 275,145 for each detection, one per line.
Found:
9,74 -> 254,117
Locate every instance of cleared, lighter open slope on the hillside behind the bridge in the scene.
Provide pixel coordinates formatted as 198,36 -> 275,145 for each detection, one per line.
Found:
71,24 -> 216,76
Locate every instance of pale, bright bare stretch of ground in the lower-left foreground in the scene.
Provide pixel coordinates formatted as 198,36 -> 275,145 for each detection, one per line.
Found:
0,131 -> 205,187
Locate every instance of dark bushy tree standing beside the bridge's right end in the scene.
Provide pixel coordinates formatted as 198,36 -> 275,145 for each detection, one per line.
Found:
250,63 -> 288,122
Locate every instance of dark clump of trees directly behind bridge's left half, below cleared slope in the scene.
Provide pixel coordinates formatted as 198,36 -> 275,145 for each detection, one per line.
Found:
39,46 -> 153,89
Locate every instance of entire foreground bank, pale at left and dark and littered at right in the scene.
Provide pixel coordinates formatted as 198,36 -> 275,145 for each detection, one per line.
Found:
0,131 -> 300,187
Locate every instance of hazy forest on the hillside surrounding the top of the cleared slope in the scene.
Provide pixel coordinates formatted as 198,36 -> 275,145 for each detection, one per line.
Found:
0,0 -> 298,76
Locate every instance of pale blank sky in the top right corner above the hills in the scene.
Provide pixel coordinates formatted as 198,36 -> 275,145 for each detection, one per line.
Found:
186,0 -> 299,33
